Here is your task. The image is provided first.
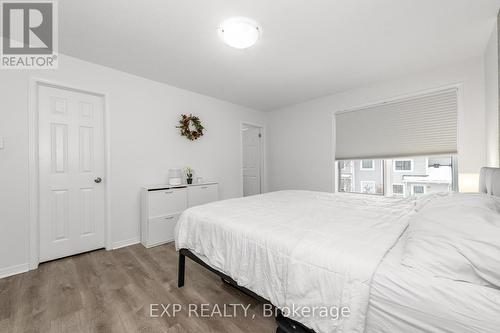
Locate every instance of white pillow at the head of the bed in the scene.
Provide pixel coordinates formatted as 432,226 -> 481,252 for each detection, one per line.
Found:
402,193 -> 500,287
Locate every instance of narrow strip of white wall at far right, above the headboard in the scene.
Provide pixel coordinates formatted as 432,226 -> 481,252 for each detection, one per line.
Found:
484,20 -> 500,167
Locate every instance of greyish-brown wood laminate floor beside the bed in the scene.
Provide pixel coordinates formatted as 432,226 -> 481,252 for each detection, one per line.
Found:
0,244 -> 276,333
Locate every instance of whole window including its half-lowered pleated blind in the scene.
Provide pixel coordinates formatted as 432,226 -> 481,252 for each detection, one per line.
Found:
335,86 -> 460,196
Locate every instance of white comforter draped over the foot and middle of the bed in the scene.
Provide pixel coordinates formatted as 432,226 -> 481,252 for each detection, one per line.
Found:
175,191 -> 414,333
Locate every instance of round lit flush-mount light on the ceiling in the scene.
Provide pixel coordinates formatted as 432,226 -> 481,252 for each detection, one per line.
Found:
219,17 -> 261,49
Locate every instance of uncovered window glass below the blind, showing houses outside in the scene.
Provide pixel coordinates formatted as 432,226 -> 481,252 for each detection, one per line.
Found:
337,155 -> 458,197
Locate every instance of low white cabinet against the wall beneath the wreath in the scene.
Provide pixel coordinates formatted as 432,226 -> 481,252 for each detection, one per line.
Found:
141,183 -> 219,247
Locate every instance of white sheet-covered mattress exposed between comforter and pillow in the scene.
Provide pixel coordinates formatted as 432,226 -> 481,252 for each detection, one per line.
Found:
366,234 -> 500,333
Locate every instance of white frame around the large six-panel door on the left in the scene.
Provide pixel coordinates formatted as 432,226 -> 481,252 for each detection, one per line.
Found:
28,78 -> 112,270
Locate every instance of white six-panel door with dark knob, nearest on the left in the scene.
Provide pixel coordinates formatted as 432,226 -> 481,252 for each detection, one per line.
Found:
38,86 -> 105,261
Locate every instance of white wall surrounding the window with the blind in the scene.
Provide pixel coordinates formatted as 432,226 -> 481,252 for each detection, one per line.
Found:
268,57 -> 486,191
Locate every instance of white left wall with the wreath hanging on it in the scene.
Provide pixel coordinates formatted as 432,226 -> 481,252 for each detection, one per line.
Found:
0,56 -> 267,275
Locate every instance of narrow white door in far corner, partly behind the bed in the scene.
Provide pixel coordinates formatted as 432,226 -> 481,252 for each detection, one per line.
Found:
242,126 -> 261,196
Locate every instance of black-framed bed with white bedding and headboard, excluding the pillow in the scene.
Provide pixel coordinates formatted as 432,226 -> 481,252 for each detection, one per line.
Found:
176,168 -> 500,333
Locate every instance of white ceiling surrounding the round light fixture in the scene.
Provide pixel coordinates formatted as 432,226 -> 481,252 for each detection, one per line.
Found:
59,0 -> 500,110
